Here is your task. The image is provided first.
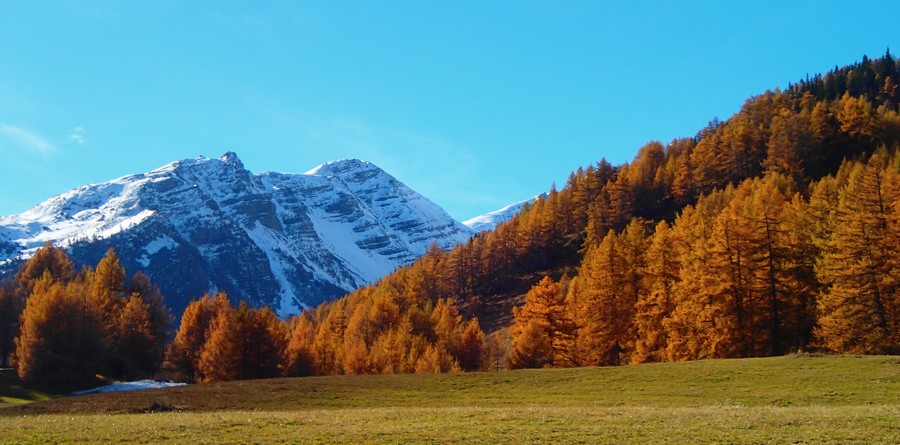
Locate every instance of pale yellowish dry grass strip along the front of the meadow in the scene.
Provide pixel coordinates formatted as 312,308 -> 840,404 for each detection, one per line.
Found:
0,406 -> 900,444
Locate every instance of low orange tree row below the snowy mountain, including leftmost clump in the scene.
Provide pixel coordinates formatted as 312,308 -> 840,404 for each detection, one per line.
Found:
0,244 -> 488,390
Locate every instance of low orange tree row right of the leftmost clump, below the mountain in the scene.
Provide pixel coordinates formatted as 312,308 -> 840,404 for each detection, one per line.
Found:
167,284 -> 488,382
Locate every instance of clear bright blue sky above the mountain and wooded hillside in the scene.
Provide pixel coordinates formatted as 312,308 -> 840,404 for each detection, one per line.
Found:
0,0 -> 900,220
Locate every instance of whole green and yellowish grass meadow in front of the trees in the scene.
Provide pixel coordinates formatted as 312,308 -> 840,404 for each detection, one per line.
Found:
0,356 -> 900,444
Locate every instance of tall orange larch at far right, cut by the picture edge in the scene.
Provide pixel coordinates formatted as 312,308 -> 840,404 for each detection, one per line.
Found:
817,153 -> 900,353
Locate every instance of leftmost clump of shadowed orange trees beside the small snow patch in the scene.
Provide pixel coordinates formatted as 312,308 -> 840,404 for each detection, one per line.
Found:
0,244 -> 172,389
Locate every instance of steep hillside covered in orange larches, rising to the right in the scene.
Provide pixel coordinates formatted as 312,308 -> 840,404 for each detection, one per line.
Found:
286,52 -> 900,373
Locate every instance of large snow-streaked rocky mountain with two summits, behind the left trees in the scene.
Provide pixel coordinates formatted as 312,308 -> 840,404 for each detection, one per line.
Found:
0,152 -> 472,316
